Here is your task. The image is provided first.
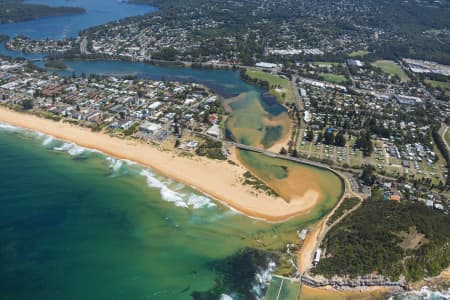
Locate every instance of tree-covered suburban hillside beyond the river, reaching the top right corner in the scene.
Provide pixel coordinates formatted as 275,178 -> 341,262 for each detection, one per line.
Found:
81,0 -> 450,65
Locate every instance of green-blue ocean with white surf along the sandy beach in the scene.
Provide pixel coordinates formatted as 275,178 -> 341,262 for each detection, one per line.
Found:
0,124 -> 295,299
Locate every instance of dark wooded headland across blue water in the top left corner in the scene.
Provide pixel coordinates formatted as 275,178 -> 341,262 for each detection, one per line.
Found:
0,0 -> 86,24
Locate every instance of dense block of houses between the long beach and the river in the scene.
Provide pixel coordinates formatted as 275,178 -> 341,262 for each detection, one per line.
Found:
0,60 -> 222,148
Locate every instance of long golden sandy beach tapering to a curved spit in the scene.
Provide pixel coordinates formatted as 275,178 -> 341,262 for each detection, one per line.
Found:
0,108 -> 326,222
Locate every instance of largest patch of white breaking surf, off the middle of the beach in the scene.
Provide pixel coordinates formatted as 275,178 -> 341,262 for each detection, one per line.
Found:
140,170 -> 216,209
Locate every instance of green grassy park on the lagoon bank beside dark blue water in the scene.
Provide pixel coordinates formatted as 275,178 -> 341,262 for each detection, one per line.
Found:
246,70 -> 295,103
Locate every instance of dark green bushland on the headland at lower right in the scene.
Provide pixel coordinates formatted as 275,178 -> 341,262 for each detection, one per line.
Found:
313,190 -> 450,281
